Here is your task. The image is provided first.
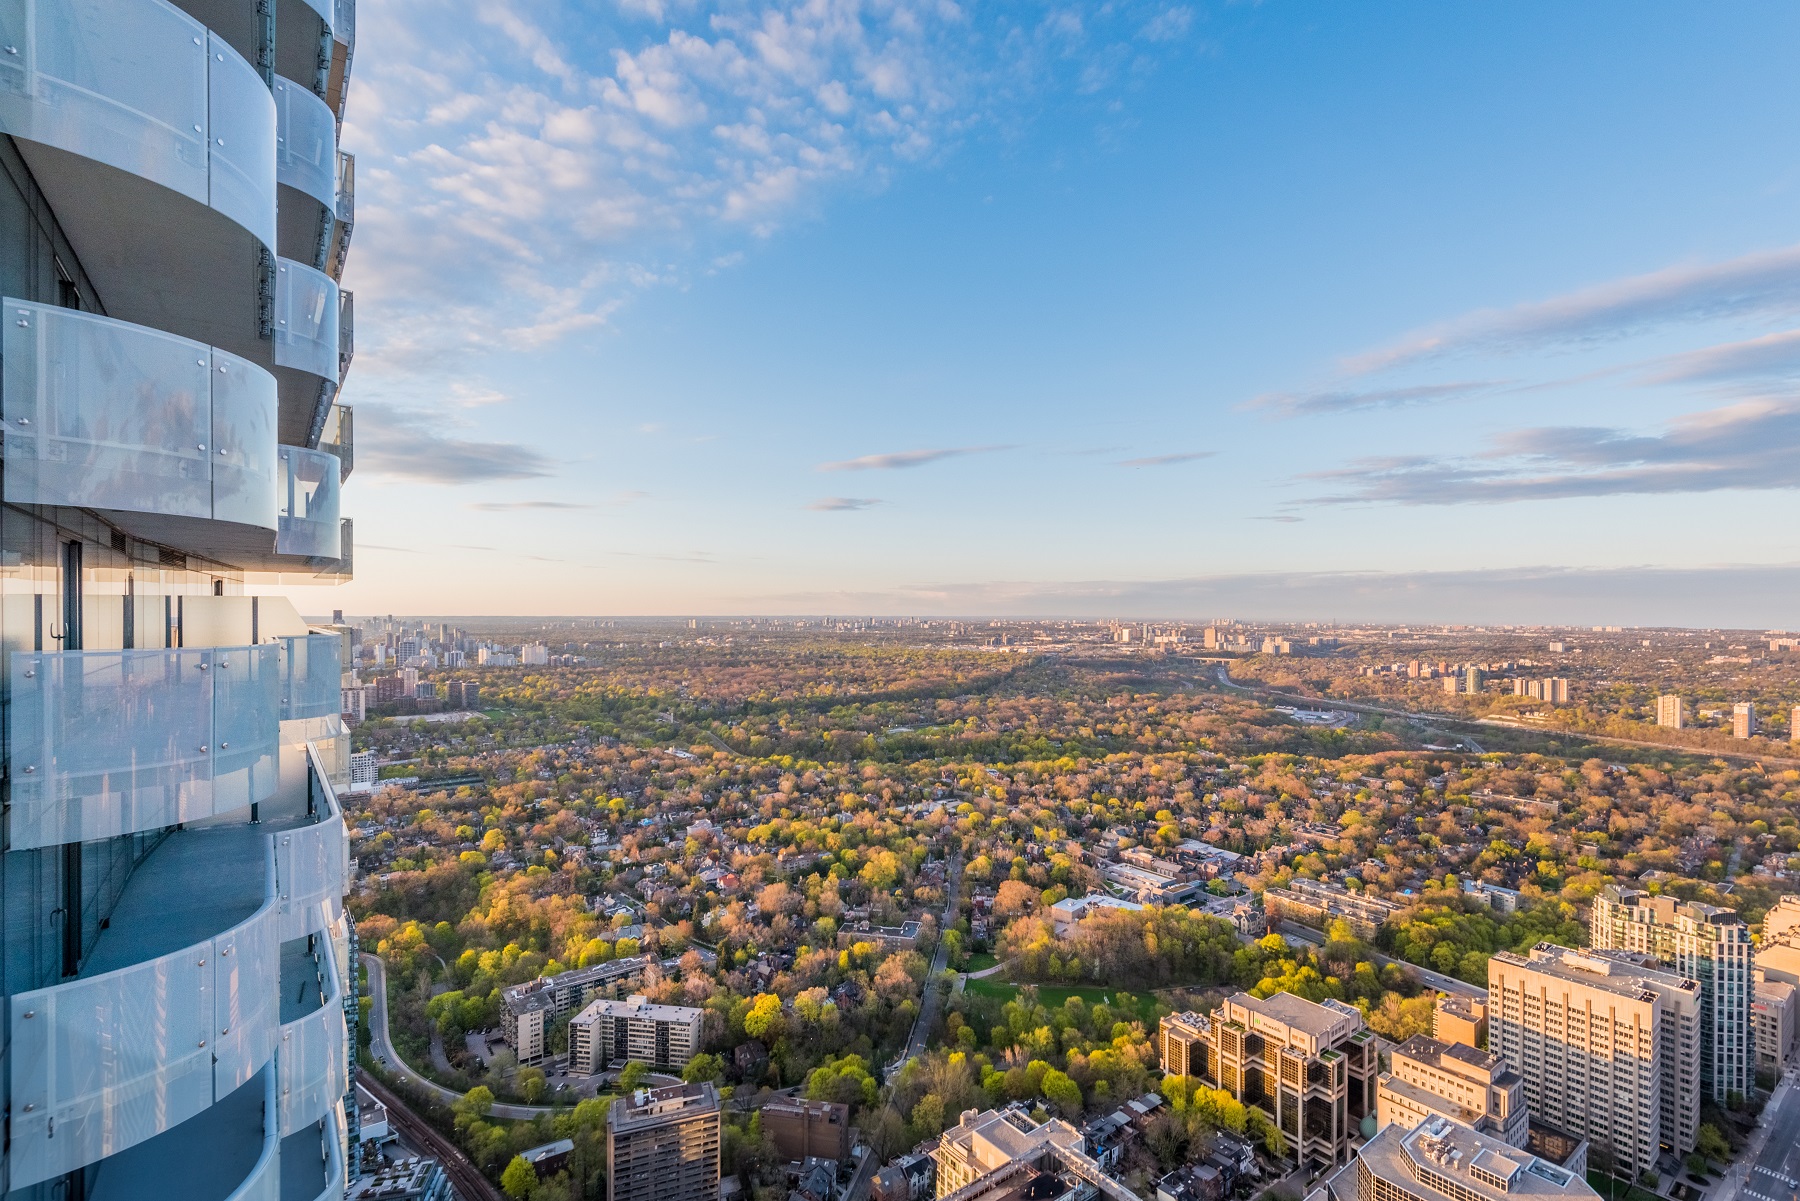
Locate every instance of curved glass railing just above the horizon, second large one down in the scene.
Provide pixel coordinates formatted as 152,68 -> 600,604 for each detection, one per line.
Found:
0,300 -> 277,529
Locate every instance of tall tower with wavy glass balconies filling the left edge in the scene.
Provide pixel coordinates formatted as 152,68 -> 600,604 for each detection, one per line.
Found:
0,0 -> 358,1201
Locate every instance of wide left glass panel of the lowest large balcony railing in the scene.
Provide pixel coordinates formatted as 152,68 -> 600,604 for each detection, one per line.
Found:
9,942 -> 214,1188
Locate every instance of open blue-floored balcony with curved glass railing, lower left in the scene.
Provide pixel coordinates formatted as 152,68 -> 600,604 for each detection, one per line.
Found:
9,753 -> 349,1197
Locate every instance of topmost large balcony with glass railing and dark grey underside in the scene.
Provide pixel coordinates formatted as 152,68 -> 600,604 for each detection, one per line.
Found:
0,0 -> 275,360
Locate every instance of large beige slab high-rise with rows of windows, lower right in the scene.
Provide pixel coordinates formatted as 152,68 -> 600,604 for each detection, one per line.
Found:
1487,944 -> 1701,1176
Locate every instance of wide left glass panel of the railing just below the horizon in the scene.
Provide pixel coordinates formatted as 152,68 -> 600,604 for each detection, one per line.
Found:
7,650 -> 214,850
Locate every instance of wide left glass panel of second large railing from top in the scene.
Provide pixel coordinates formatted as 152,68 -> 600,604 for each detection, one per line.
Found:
0,299 -> 210,517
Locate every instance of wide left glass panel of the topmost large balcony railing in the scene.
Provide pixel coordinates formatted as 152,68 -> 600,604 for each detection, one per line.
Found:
0,0 -> 208,204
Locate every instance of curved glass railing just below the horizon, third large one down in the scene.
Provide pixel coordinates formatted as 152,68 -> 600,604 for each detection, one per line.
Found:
7,643 -> 281,850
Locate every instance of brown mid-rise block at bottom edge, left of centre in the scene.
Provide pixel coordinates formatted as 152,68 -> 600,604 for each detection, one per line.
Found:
607,1082 -> 720,1201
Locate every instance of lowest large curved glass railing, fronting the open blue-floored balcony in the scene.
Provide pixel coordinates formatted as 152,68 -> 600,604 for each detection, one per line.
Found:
9,842 -> 280,1188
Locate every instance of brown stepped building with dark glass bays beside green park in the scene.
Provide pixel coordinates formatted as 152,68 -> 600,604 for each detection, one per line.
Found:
1157,992 -> 1379,1165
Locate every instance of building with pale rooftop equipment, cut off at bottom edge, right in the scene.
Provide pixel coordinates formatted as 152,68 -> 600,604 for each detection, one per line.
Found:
1355,1116 -> 1600,1201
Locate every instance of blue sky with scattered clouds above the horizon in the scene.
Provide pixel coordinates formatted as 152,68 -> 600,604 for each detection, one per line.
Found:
316,0 -> 1800,628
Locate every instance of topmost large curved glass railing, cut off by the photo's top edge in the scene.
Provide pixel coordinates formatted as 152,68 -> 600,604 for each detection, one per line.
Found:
0,0 -> 275,248
